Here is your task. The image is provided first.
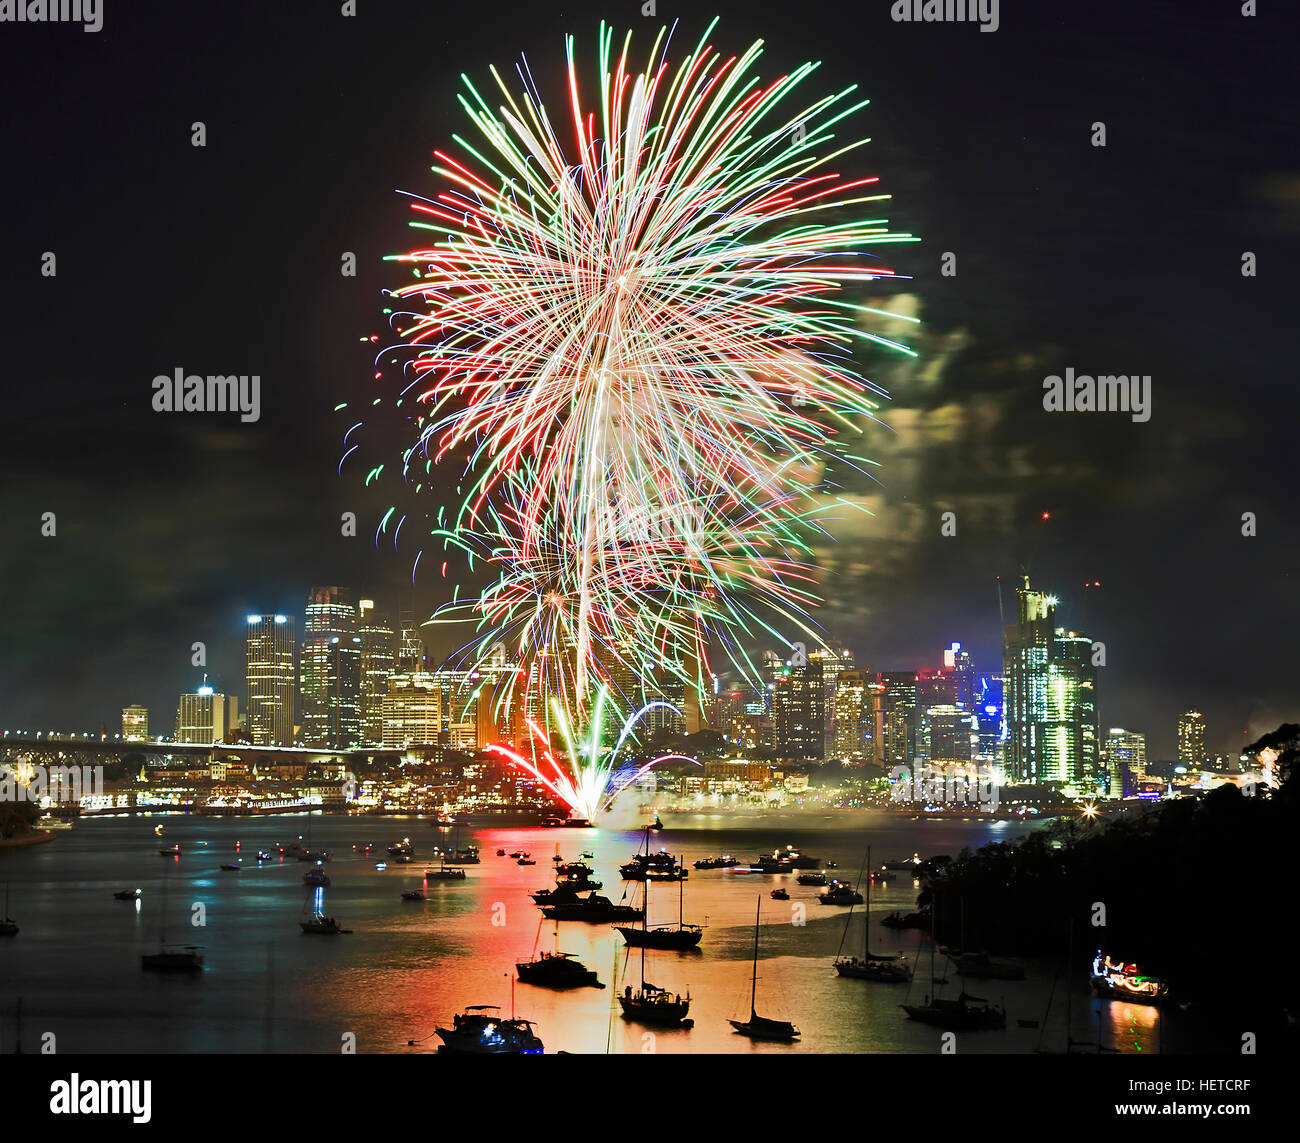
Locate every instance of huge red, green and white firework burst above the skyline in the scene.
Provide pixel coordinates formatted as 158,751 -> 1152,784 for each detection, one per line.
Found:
354,26 -> 915,805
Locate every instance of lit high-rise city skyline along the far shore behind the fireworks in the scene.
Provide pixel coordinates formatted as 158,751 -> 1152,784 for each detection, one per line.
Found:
7,577 -> 1235,782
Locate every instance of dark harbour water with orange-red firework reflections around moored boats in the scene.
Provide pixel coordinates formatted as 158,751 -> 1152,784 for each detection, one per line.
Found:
0,811 -> 1162,1055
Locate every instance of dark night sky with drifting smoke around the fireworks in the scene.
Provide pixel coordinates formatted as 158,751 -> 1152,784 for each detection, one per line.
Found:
0,0 -> 1300,758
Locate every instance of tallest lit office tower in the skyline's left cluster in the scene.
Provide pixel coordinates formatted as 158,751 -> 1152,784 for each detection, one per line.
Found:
299,588 -> 361,746
